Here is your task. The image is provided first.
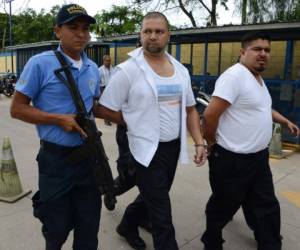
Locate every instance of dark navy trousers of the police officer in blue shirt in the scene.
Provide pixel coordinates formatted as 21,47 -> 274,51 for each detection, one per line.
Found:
33,144 -> 101,250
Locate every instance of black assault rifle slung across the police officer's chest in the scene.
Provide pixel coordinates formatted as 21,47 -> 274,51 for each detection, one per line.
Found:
54,51 -> 117,210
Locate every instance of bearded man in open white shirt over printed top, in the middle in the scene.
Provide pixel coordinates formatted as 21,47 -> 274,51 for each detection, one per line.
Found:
95,12 -> 206,250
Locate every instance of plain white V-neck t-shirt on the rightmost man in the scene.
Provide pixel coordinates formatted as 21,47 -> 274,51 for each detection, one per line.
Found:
212,63 -> 272,154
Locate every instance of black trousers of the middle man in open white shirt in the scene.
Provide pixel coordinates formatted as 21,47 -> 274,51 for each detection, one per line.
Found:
121,140 -> 180,250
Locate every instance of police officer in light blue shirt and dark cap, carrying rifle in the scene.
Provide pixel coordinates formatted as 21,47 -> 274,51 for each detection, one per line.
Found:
11,4 -> 101,250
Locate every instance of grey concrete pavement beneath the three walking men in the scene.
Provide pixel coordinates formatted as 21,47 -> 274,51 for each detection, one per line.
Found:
0,96 -> 300,250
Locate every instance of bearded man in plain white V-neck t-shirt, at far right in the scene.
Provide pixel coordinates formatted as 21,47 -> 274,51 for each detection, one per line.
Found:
201,32 -> 299,250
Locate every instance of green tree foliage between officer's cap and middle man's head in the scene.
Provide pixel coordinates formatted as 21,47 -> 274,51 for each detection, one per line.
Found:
92,5 -> 143,36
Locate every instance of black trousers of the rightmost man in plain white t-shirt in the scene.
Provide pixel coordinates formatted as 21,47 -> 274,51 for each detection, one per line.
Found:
201,145 -> 281,250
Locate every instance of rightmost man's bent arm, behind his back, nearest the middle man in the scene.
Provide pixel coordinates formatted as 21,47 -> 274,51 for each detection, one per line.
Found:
204,96 -> 230,147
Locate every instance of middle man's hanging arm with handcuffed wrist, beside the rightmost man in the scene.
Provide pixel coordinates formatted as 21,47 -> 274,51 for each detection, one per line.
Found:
186,106 -> 206,166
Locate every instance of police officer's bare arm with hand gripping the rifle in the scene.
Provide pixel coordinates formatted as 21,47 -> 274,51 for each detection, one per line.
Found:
10,91 -> 86,136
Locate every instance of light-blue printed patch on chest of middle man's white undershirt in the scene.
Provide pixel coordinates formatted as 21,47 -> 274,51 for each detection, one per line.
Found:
157,84 -> 182,105
